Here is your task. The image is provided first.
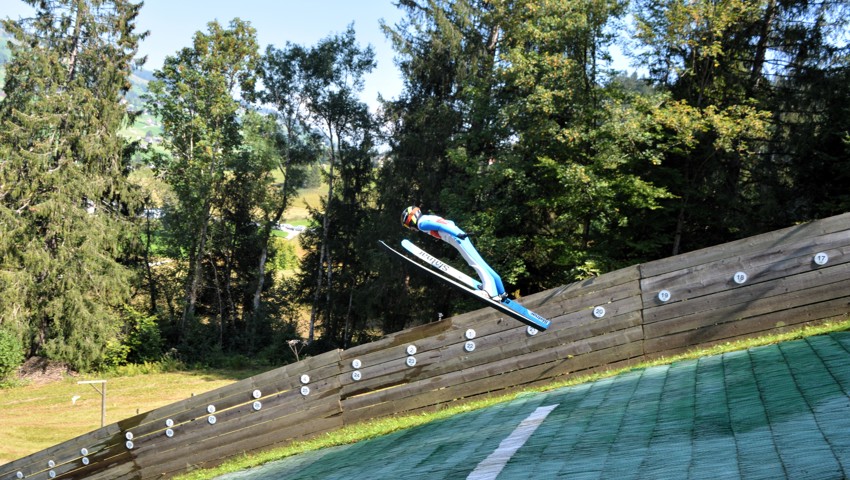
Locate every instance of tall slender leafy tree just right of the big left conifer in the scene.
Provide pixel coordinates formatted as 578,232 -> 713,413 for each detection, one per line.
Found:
148,19 -> 259,344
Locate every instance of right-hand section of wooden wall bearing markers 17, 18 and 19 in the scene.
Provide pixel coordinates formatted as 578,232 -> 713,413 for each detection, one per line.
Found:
640,214 -> 850,357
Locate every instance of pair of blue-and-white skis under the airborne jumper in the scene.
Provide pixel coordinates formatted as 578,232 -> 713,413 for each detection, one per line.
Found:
378,240 -> 550,331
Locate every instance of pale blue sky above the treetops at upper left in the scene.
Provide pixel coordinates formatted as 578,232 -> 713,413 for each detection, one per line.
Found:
0,0 -> 402,107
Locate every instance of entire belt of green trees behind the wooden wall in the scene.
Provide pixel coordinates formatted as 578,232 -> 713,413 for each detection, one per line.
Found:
0,0 -> 850,369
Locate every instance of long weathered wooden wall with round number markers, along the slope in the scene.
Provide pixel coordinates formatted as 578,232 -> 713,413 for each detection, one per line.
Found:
0,214 -> 850,480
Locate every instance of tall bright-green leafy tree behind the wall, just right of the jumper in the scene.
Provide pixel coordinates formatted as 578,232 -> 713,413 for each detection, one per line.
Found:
484,1 -> 670,282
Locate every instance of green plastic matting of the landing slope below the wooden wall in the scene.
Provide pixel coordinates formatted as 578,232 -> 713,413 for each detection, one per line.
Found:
217,333 -> 850,479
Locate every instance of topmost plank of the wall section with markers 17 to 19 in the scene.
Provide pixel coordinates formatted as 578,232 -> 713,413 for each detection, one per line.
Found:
640,213 -> 850,278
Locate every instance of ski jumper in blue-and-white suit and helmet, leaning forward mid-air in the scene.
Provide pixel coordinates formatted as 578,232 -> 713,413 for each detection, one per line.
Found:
401,207 -> 507,301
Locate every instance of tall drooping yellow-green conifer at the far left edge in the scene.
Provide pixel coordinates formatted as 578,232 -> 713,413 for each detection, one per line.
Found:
0,0 -> 144,369
